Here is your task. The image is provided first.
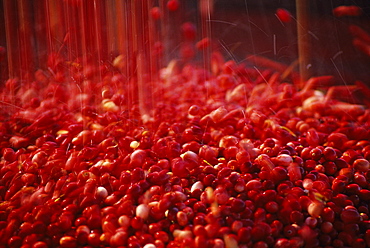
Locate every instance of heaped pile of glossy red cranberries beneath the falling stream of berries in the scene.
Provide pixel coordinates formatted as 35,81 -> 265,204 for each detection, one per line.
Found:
0,49 -> 370,248
